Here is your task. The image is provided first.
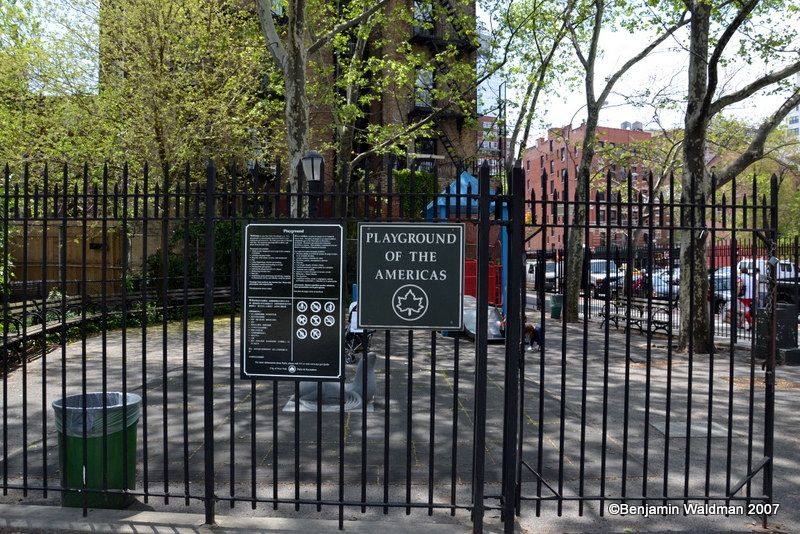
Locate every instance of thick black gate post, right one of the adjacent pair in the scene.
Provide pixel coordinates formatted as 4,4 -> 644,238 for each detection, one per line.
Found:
503,165 -> 525,534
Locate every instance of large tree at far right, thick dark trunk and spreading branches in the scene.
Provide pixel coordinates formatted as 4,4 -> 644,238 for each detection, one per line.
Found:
678,0 -> 800,353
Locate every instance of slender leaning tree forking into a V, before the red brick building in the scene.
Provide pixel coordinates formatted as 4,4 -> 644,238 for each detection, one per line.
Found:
564,0 -> 688,322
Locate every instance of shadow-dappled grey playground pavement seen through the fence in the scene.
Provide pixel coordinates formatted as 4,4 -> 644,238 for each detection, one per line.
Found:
0,312 -> 800,532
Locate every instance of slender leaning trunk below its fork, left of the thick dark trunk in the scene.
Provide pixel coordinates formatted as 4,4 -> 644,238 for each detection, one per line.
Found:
564,106 -> 600,323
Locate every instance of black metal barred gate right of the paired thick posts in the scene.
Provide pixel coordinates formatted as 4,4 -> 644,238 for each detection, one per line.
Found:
502,168 -> 780,532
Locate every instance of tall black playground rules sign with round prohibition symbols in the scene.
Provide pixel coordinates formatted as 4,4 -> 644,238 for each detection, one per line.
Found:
241,223 -> 344,380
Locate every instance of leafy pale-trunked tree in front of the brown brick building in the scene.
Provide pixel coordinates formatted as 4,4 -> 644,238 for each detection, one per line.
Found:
256,0 -> 527,218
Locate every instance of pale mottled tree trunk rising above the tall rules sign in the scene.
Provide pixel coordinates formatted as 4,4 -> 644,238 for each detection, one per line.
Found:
284,0 -> 310,217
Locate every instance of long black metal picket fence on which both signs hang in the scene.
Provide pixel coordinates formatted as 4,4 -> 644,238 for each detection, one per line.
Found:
2,161 -> 797,531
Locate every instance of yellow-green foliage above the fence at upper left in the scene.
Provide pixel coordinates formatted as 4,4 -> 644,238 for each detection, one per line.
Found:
0,0 -> 282,165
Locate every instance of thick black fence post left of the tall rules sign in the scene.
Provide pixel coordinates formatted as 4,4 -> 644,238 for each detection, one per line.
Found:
203,161 -> 217,525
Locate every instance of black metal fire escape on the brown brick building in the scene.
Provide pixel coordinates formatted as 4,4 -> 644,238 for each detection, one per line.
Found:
409,0 -> 477,169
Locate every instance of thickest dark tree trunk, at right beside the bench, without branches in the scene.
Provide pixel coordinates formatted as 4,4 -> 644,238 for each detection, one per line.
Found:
678,2 -> 712,354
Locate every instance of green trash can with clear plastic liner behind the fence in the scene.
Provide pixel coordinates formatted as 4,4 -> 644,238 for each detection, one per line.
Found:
53,392 -> 142,508
